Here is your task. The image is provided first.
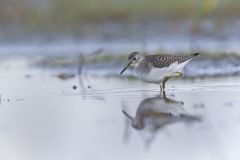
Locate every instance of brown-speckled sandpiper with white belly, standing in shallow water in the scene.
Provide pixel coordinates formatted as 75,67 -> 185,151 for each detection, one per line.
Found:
120,52 -> 199,91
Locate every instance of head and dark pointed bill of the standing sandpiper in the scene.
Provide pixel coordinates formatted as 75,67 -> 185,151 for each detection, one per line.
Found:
120,52 -> 144,74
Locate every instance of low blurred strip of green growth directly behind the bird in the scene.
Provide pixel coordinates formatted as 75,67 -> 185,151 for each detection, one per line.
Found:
36,52 -> 240,68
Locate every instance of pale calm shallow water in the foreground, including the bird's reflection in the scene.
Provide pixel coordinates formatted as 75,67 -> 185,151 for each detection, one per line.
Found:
0,59 -> 240,160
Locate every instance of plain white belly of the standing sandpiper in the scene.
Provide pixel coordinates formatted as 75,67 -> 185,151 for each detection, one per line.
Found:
137,60 -> 190,83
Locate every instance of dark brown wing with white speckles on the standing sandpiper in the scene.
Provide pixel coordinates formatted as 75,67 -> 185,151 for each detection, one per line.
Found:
146,54 -> 197,68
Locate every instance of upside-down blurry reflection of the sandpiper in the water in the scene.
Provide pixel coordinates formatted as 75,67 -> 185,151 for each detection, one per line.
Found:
122,92 -> 200,148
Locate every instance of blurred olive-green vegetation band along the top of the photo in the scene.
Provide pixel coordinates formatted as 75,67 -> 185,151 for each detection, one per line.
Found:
0,0 -> 240,30
